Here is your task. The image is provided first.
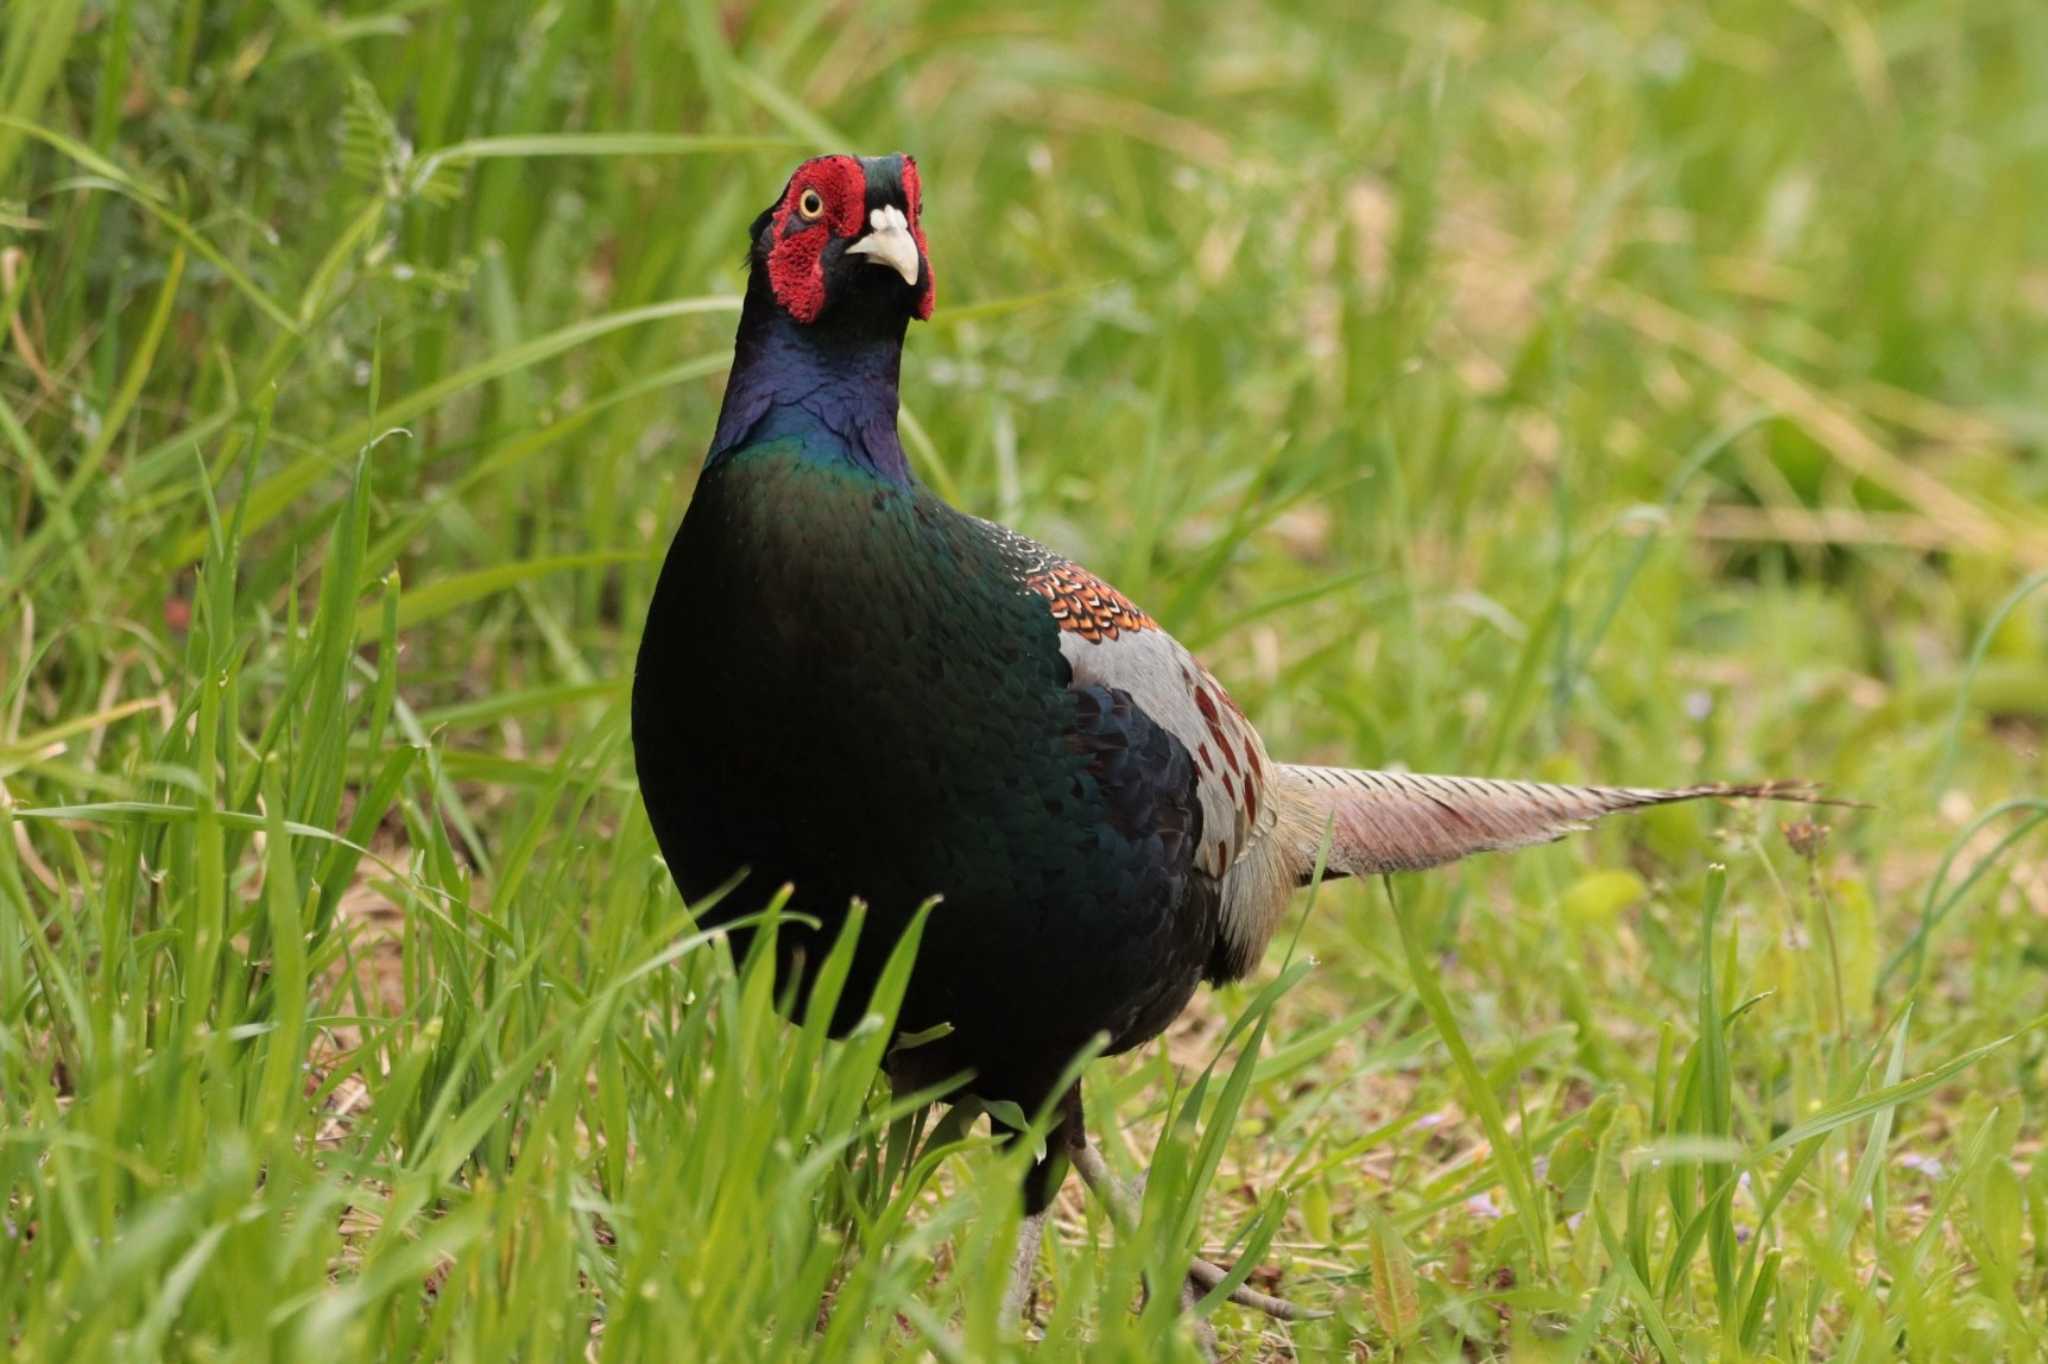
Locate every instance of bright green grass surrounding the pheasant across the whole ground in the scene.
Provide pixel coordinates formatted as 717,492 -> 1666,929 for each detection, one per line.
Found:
0,0 -> 2048,1360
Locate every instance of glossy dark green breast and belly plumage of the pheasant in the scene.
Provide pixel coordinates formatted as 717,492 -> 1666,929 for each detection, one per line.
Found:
633,436 -> 1219,1106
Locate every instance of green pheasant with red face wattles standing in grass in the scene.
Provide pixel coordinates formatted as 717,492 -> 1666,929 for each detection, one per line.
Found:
633,156 -> 1810,1335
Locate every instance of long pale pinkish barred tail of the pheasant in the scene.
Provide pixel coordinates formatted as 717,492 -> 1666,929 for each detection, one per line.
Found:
1276,766 -> 1855,881
